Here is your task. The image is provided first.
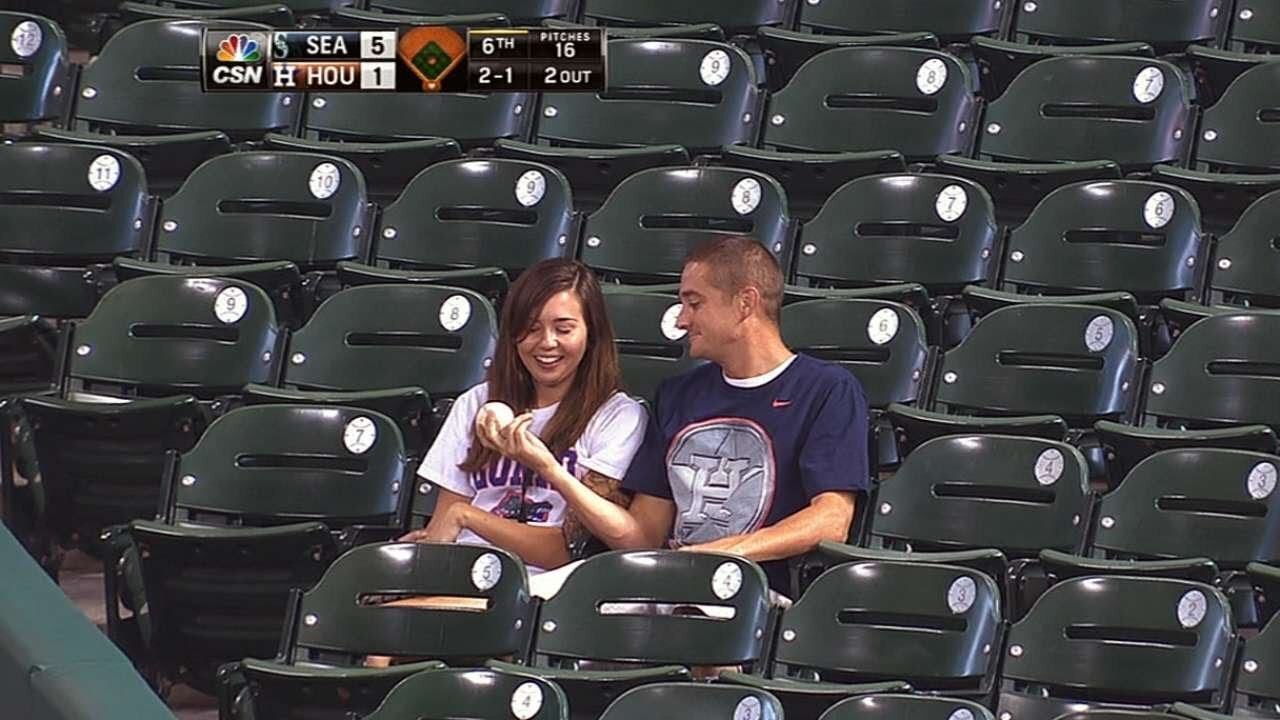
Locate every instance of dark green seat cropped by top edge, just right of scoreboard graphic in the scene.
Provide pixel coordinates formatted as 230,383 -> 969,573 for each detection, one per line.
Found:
582,0 -> 799,35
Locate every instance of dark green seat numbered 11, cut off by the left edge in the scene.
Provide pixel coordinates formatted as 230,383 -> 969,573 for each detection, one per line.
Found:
0,142 -> 151,318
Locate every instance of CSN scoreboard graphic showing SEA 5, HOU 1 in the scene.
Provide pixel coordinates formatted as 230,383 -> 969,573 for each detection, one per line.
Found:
201,26 -> 605,92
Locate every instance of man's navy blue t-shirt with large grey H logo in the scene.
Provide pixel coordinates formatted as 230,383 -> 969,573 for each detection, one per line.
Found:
622,355 -> 869,593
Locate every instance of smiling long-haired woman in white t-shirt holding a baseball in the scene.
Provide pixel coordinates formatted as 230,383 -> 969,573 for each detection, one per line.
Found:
401,259 -> 648,574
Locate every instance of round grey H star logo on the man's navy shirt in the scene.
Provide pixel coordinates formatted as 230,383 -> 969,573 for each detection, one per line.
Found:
667,418 -> 777,546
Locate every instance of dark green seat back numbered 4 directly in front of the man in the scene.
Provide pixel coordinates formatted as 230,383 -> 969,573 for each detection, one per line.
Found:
534,550 -> 769,666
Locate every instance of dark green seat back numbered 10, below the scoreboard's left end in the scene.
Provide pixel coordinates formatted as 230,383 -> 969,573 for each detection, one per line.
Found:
156,152 -> 370,269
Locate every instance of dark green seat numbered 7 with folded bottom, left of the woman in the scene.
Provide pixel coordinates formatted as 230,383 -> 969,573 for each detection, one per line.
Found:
114,405 -> 410,692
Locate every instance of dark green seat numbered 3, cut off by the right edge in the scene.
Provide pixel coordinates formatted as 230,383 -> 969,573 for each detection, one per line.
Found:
1042,447 -> 1280,626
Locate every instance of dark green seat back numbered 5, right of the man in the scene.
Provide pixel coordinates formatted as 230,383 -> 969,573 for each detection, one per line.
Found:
934,304 -> 1138,425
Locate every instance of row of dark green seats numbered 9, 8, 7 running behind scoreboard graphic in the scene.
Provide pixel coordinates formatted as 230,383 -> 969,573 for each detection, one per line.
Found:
0,15 -> 1280,217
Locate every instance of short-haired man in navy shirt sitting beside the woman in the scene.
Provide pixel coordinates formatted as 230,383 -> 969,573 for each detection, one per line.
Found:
557,237 -> 869,594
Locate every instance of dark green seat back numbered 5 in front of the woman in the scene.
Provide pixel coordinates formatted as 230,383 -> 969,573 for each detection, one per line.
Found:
288,543 -> 532,666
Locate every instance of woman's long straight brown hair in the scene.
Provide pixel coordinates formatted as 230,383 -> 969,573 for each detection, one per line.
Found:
458,259 -> 622,473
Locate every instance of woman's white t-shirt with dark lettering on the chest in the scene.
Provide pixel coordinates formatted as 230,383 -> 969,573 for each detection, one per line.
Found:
417,383 -> 648,571
